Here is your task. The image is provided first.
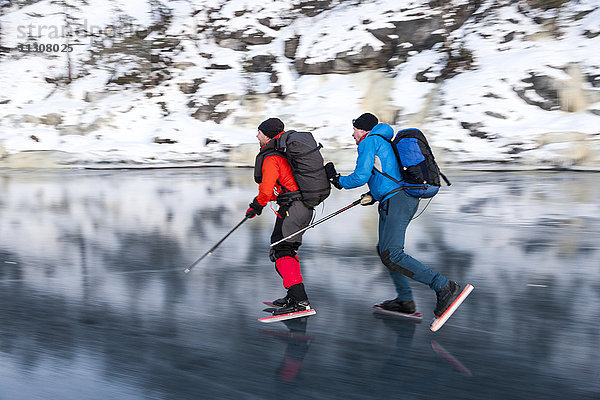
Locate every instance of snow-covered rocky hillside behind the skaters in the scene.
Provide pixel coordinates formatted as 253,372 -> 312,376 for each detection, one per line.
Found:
0,0 -> 600,169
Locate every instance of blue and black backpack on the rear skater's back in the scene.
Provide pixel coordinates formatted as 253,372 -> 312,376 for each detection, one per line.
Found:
376,128 -> 451,198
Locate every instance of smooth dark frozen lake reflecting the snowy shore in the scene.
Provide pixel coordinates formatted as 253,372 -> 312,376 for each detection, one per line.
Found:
0,168 -> 600,400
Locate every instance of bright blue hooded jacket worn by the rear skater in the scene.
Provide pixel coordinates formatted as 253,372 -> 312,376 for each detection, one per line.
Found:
339,123 -> 404,201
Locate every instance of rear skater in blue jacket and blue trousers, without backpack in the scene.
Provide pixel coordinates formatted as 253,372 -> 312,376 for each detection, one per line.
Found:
325,113 -> 460,317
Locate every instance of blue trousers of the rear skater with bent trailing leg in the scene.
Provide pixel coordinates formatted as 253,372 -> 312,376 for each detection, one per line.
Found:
377,191 -> 448,301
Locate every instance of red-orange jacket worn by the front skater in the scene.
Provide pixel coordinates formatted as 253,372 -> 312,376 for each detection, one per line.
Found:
254,132 -> 300,207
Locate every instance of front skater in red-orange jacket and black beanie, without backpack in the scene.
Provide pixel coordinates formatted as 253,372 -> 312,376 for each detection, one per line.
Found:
246,118 -> 313,315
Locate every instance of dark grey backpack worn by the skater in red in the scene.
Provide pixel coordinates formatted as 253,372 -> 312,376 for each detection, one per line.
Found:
275,130 -> 331,208
